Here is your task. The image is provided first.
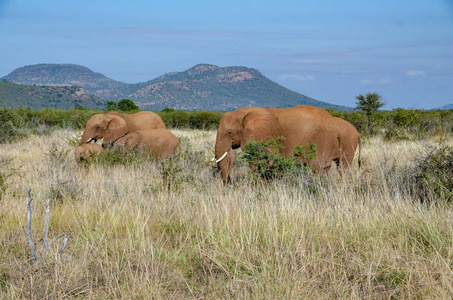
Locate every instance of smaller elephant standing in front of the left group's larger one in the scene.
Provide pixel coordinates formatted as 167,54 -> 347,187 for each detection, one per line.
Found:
113,128 -> 179,158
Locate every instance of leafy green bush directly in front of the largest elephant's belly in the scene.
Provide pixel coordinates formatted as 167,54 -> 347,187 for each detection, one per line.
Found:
242,137 -> 316,180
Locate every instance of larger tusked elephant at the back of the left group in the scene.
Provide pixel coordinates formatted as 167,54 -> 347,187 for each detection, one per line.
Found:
82,111 -> 167,145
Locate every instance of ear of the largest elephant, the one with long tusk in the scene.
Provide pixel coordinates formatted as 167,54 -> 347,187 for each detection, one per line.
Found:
241,108 -> 279,147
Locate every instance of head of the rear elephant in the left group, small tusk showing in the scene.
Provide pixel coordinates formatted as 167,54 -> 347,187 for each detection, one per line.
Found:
82,114 -> 128,144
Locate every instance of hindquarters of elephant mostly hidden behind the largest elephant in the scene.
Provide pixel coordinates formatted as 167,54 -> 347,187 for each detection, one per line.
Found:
333,117 -> 362,168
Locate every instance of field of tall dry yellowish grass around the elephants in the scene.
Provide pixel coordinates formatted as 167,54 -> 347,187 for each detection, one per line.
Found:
0,129 -> 453,299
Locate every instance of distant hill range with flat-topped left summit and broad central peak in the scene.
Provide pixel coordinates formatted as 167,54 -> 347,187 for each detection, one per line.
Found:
0,64 -> 350,111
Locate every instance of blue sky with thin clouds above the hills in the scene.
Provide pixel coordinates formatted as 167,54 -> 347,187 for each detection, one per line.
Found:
0,0 -> 453,109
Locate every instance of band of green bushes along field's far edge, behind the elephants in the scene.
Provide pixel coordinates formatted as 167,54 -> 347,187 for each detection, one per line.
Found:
0,105 -> 453,135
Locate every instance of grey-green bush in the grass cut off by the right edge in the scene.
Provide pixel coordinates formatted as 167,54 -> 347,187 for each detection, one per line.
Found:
413,145 -> 453,201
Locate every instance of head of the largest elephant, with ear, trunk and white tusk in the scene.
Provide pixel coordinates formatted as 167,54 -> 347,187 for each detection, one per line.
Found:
215,107 -> 278,184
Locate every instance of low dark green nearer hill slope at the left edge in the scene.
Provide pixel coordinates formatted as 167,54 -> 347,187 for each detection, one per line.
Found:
0,80 -> 105,109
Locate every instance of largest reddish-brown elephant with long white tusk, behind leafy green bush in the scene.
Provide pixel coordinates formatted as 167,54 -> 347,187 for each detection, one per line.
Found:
215,105 -> 358,184
